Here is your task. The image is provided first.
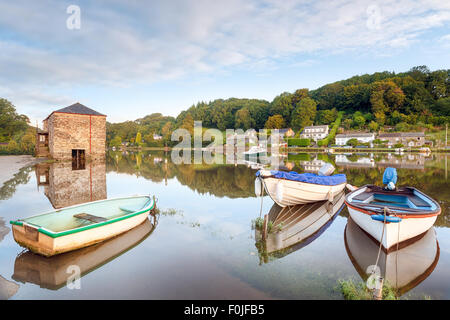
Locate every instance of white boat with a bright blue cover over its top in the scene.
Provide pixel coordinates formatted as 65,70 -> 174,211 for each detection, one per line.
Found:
255,170 -> 347,207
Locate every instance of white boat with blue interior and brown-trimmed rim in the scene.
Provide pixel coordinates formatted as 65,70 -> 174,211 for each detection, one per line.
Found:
345,185 -> 441,251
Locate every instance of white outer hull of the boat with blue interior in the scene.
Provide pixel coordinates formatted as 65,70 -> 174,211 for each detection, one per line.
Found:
347,204 -> 437,251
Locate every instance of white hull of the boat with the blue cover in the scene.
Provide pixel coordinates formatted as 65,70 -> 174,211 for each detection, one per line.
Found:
263,177 -> 346,207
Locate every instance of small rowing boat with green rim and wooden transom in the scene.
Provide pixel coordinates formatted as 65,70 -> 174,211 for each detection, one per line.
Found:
11,196 -> 155,256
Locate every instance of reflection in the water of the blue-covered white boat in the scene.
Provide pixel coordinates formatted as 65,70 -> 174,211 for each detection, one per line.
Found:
255,191 -> 345,264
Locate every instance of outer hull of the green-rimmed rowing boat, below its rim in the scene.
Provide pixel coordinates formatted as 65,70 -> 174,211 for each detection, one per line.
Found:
12,205 -> 150,257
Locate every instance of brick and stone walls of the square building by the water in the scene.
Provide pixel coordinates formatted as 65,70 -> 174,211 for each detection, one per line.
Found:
44,112 -> 106,160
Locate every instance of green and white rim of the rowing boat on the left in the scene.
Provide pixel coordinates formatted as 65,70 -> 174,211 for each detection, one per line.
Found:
10,195 -> 155,238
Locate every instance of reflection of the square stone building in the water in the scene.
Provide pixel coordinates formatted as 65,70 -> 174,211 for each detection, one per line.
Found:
35,161 -> 106,209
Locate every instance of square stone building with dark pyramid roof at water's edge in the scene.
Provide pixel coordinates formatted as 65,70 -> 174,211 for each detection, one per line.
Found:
36,102 -> 106,160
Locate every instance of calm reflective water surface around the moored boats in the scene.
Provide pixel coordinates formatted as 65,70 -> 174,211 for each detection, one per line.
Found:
0,152 -> 450,299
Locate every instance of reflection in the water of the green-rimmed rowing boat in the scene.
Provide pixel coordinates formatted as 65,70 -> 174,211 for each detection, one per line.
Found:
12,215 -> 158,290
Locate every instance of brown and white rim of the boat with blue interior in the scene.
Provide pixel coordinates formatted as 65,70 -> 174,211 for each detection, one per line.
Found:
345,184 -> 441,219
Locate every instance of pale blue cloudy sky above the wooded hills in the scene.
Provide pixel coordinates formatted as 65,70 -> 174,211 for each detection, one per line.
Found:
0,0 -> 450,125
